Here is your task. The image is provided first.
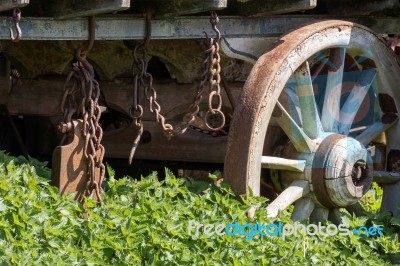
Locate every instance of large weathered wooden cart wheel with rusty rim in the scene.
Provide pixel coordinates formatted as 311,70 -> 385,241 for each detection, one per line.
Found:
224,21 -> 400,221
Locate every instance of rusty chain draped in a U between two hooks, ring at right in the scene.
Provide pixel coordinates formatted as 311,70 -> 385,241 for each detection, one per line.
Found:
129,11 -> 225,163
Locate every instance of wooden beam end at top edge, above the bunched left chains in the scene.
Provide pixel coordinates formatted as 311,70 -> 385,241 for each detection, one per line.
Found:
49,0 -> 130,19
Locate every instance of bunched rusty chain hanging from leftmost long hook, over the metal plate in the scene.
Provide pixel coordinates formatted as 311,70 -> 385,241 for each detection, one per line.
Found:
59,17 -> 105,204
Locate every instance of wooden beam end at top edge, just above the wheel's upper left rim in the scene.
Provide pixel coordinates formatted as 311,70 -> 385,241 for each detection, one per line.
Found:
232,0 -> 317,16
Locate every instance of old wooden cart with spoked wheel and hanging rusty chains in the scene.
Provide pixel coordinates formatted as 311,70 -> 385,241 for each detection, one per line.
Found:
0,0 -> 400,221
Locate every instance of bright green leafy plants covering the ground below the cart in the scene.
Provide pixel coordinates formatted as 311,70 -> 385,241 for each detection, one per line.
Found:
0,152 -> 400,265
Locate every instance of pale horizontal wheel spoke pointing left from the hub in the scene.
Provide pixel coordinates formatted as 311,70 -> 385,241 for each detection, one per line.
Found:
261,156 -> 306,173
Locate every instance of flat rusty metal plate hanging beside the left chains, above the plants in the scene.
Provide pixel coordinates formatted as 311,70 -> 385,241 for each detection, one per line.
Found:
52,120 -> 103,204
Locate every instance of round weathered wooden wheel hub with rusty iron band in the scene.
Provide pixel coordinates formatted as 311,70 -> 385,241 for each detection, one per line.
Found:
311,134 -> 372,208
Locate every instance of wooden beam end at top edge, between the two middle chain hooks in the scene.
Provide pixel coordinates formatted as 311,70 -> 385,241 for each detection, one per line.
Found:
155,0 -> 228,18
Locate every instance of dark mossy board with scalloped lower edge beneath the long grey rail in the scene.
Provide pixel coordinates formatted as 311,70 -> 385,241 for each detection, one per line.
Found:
2,40 -> 209,83
